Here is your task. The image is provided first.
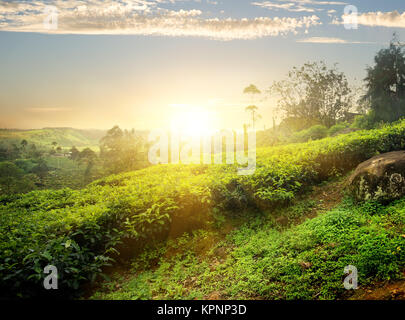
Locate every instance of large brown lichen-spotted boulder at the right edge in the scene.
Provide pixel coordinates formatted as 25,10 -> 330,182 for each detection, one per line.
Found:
349,151 -> 405,202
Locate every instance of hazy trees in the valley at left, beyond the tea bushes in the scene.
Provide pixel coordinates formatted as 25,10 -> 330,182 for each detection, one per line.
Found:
0,126 -> 149,195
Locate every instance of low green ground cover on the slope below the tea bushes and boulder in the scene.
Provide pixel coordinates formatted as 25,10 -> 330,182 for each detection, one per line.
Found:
91,191 -> 405,299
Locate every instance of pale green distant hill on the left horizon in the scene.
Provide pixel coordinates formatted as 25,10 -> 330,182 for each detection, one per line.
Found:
0,128 -> 106,148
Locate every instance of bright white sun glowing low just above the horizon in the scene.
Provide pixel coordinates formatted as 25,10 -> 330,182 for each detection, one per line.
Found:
170,109 -> 214,137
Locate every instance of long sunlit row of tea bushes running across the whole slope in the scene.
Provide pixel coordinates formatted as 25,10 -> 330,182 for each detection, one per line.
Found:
0,121 -> 405,294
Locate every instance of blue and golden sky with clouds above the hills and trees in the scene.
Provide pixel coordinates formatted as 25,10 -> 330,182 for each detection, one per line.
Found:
0,0 -> 405,129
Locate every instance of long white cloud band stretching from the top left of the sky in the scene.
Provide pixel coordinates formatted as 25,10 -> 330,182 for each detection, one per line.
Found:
0,0 -> 321,40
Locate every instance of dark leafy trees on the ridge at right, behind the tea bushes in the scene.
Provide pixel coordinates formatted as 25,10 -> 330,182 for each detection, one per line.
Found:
258,35 -> 405,146
